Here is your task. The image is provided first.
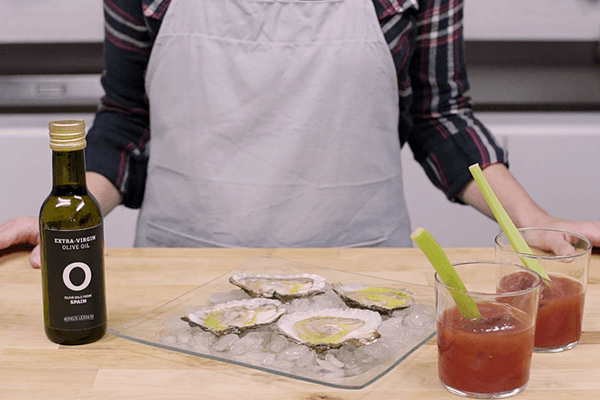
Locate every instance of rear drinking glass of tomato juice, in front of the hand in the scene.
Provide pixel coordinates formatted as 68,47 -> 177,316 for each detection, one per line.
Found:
495,228 -> 592,352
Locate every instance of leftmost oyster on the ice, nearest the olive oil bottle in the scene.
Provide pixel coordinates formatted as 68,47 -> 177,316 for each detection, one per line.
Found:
181,299 -> 285,336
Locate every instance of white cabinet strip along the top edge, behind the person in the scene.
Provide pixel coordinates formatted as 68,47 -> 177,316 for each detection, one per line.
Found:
0,0 -> 600,43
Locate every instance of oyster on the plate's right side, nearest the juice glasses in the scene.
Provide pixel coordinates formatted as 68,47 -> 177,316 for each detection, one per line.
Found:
331,283 -> 414,314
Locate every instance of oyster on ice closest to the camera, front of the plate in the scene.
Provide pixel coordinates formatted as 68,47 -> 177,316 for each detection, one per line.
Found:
277,308 -> 381,351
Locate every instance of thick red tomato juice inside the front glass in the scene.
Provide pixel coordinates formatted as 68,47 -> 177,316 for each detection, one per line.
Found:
437,302 -> 534,393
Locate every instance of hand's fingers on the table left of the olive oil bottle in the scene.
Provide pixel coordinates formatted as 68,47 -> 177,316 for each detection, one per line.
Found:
0,217 -> 42,268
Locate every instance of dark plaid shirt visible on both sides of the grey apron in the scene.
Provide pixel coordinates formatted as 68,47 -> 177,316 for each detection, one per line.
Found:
86,0 -> 507,208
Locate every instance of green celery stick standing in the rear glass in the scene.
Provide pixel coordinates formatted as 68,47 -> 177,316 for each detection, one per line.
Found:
469,164 -> 550,281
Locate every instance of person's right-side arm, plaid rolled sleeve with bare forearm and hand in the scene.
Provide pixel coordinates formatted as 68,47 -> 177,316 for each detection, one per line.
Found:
408,0 -> 600,247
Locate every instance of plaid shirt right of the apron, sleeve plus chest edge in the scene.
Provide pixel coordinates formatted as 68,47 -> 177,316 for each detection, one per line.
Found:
374,0 -> 508,202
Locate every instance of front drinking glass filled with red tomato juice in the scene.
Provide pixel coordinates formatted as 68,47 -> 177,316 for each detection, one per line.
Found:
435,261 -> 541,399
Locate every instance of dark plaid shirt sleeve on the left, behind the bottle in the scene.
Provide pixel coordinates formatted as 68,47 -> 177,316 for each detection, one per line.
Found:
86,0 -> 164,208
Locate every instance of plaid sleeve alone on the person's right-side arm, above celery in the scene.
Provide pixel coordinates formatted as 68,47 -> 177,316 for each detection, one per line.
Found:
401,0 -> 508,202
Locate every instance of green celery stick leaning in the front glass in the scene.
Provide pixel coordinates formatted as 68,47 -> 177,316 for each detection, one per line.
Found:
410,228 -> 481,319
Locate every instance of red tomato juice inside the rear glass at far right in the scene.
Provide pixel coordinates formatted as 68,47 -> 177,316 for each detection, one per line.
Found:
499,273 -> 585,349
